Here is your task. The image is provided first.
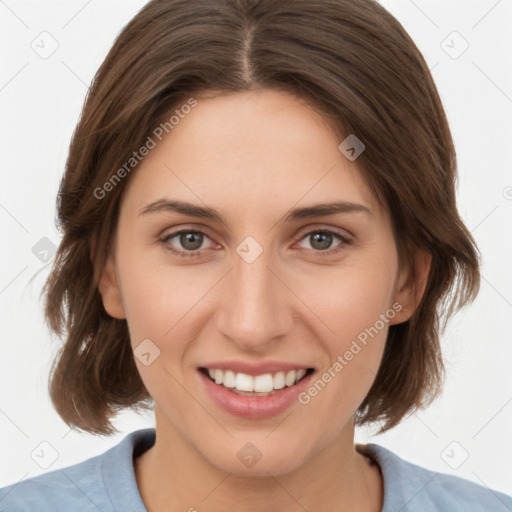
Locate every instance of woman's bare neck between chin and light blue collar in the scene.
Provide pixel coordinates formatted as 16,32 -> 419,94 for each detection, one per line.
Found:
134,414 -> 383,512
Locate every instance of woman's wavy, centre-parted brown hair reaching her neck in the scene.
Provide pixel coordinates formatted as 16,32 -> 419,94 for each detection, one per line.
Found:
43,0 -> 479,434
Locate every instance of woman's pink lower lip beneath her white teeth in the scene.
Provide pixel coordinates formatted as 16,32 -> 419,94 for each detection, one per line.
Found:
199,371 -> 314,420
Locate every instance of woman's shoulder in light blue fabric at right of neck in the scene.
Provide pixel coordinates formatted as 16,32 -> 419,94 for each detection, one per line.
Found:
357,444 -> 512,512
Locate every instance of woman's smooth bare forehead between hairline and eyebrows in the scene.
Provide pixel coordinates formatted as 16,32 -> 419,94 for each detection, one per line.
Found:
124,90 -> 384,221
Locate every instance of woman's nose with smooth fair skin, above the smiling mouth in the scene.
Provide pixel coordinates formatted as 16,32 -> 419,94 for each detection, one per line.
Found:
216,243 -> 294,351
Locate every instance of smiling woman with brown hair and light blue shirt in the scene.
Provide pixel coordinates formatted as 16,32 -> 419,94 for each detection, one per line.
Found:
0,0 -> 512,512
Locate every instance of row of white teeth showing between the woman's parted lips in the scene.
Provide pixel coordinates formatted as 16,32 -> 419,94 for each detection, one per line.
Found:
199,368 -> 314,396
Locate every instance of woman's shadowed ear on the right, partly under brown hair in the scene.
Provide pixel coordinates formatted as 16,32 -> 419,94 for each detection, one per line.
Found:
389,249 -> 432,325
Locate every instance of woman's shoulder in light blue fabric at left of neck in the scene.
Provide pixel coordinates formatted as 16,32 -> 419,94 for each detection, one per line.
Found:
0,429 -> 154,512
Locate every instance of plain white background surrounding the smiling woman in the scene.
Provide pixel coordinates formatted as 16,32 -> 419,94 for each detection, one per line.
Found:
0,0 -> 512,500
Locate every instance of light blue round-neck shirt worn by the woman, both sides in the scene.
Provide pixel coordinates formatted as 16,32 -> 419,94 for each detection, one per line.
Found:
0,428 -> 512,512
